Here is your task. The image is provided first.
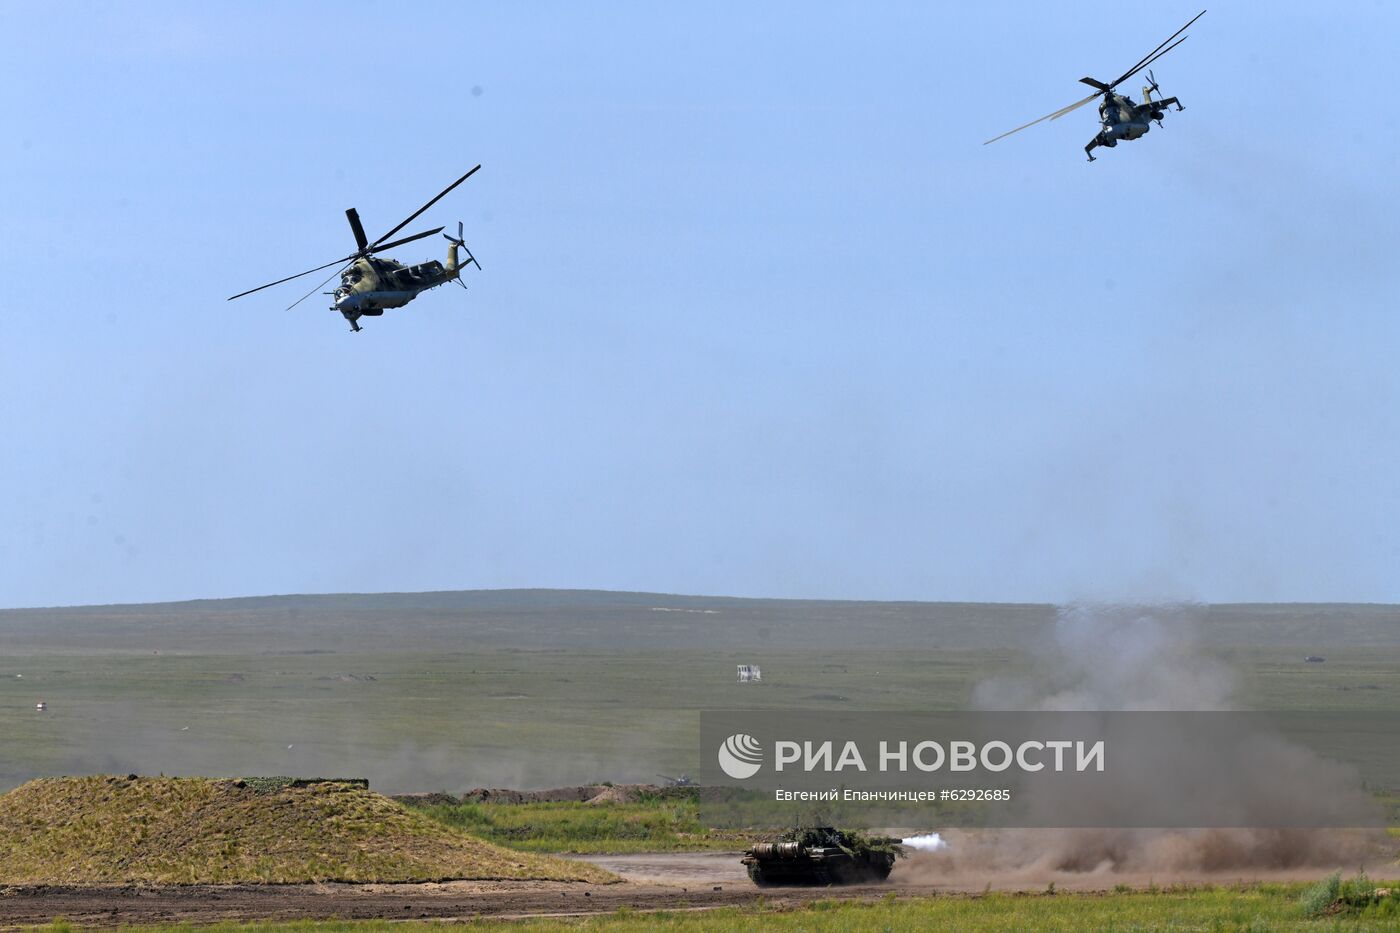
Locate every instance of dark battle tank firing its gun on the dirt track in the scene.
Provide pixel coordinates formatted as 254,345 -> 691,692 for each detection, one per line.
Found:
743,827 -> 904,888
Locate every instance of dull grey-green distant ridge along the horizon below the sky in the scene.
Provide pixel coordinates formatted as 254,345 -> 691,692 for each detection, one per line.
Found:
0,590 -> 1400,650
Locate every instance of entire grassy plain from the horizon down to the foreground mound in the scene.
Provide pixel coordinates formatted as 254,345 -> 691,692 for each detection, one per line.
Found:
0,591 -> 1400,793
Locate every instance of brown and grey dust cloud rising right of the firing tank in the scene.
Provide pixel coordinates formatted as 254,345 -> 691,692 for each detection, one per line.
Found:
899,604 -> 1394,887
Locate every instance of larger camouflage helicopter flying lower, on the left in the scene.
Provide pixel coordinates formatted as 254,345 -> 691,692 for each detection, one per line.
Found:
228,165 -> 482,333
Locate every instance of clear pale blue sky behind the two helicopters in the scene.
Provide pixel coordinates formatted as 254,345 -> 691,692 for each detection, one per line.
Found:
0,1 -> 1400,607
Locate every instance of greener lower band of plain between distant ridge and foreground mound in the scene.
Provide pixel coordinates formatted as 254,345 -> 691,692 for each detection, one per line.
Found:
8,636 -> 1400,793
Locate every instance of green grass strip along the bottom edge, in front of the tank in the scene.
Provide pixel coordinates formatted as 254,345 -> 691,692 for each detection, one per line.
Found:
19,885 -> 1400,933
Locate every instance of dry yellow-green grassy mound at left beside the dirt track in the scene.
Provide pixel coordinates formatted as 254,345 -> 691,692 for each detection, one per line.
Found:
0,776 -> 616,884
